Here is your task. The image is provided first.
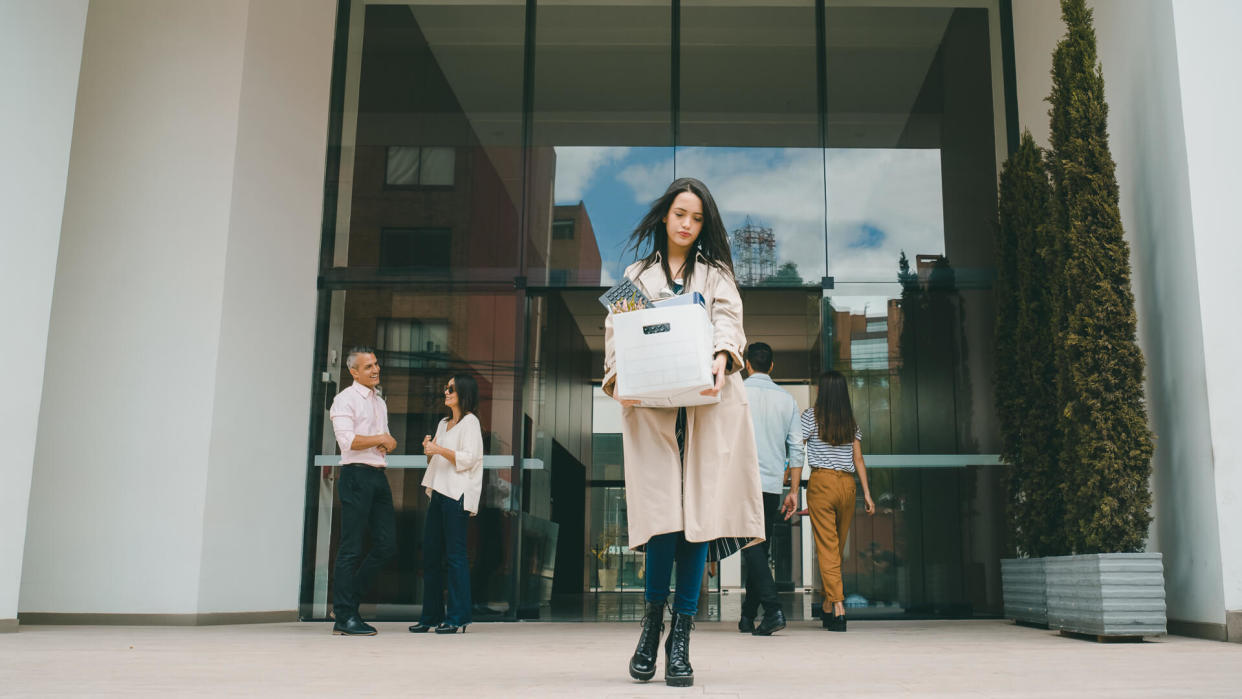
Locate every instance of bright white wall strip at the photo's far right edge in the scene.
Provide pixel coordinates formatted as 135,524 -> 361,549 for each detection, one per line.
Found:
1172,0 -> 1242,610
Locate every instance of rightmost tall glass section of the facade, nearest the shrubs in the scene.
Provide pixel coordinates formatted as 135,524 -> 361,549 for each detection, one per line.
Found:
825,4 -> 1001,615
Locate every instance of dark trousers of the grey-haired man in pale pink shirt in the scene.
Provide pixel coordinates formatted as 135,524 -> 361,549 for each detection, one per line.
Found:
332,464 -> 396,621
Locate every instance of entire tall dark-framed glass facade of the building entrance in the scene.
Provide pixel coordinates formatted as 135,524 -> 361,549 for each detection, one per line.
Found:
302,0 -> 1007,621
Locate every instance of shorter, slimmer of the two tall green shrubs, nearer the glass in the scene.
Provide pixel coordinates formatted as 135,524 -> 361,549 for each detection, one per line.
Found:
995,132 -> 1067,556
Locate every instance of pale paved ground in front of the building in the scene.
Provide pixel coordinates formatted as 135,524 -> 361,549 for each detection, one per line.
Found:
0,621 -> 1242,698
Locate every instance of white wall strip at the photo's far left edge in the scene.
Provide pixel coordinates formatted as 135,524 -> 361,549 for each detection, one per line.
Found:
0,0 -> 87,622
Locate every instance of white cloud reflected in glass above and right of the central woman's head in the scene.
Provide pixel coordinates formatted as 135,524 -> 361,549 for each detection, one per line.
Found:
601,148 -> 944,283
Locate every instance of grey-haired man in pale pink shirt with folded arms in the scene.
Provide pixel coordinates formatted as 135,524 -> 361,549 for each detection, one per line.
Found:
328,348 -> 396,636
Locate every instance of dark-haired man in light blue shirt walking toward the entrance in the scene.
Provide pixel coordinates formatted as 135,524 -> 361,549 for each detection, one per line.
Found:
738,343 -> 802,636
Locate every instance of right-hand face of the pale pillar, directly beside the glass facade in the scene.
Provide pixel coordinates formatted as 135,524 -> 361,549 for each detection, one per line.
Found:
199,0 -> 337,612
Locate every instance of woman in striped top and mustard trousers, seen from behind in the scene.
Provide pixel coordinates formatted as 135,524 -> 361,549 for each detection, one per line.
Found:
784,371 -> 876,631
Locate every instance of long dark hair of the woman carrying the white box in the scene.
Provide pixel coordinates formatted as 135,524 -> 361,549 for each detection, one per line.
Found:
627,178 -> 733,286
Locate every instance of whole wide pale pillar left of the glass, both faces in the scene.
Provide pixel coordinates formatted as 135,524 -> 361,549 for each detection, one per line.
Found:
20,0 -> 334,615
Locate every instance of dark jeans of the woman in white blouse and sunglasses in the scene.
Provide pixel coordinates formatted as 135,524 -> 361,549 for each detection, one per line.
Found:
419,490 -> 471,626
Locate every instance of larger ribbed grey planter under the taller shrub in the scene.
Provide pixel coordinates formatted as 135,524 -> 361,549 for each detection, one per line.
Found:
1048,554 -> 1167,636
